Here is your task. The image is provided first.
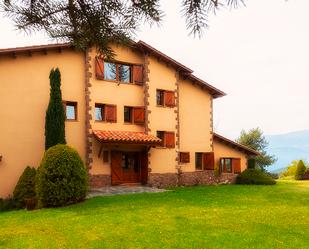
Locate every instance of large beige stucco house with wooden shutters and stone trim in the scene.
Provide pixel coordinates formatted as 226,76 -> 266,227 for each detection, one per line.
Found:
0,41 -> 257,197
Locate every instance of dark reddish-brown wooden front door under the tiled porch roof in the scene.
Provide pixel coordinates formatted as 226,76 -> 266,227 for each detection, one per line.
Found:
111,151 -> 141,184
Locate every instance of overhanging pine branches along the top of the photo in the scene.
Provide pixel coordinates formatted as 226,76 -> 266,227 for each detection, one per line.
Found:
1,0 -> 245,57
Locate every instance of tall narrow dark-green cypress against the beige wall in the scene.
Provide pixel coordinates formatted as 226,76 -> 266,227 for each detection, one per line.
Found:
45,68 -> 66,150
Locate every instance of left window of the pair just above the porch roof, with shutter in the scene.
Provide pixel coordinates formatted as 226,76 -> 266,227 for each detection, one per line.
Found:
94,103 -> 117,122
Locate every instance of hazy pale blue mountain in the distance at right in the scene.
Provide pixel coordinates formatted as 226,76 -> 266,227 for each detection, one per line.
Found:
266,130 -> 309,172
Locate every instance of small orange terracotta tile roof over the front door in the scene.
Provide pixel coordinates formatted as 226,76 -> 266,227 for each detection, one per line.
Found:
93,130 -> 161,145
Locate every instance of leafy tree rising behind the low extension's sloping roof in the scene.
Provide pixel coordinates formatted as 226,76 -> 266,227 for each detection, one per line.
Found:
237,128 -> 277,170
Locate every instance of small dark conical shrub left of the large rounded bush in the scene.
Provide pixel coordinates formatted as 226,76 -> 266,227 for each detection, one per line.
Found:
13,166 -> 36,208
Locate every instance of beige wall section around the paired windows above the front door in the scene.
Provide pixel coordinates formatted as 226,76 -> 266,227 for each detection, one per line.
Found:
90,45 -> 145,174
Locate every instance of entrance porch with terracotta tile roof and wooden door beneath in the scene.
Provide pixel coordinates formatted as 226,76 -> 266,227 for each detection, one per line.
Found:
92,130 -> 161,187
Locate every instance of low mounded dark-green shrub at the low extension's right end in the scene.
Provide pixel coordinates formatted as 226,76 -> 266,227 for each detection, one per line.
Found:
236,169 -> 276,185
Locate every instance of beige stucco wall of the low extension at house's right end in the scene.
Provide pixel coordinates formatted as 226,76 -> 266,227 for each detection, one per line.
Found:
213,139 -> 247,171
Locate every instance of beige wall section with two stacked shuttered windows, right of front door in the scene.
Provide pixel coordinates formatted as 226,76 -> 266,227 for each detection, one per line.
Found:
148,56 -> 177,173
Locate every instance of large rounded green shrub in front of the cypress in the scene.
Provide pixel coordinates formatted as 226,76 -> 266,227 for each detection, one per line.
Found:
36,144 -> 88,207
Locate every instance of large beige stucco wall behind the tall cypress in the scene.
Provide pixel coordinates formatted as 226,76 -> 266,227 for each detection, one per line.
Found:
0,50 -> 85,197
